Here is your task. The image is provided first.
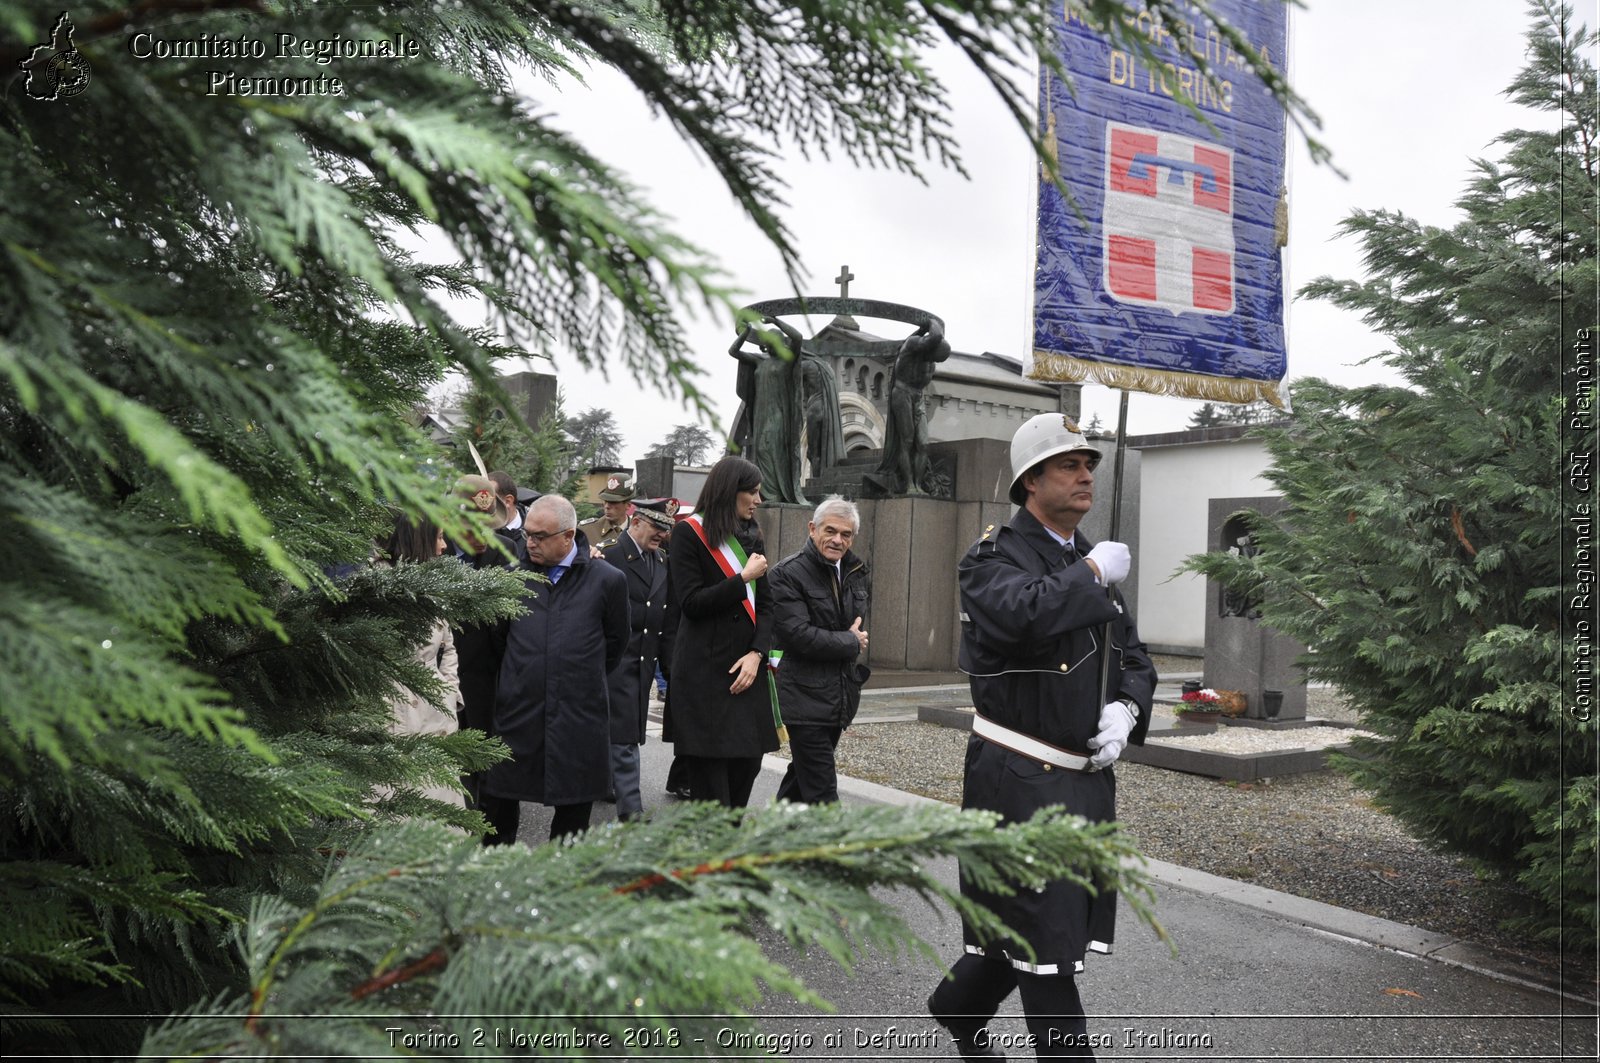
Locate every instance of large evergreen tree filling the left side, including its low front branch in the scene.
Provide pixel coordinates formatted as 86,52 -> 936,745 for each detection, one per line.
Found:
0,0 -> 1283,1057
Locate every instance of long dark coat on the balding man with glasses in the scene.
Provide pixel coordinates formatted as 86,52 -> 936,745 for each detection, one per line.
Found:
486,532 -> 627,805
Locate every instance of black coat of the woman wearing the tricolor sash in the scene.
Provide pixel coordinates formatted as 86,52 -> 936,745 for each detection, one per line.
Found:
662,522 -> 778,757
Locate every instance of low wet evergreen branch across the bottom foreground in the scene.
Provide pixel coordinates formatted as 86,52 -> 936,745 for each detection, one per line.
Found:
142,804 -> 1150,1058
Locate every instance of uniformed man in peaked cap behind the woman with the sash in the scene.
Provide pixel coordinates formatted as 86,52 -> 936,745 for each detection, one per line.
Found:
602,498 -> 678,820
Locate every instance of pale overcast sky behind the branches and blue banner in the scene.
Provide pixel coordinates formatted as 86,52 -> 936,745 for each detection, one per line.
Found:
496,0 -> 1548,464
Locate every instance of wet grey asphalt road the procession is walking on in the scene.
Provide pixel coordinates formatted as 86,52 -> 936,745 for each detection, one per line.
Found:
505,717 -> 1597,1061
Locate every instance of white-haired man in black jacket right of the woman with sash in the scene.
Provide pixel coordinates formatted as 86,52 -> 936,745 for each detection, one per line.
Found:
770,496 -> 869,805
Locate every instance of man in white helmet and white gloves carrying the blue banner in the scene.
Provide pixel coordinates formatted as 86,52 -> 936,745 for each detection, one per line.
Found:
928,413 -> 1155,1060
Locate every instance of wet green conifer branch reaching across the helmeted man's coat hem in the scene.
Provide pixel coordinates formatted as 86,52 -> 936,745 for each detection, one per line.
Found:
156,805 -> 1154,1055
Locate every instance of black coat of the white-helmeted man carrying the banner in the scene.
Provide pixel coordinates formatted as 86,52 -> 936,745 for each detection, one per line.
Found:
958,509 -> 1155,975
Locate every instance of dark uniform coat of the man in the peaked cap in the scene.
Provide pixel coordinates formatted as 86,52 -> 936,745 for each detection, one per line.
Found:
602,533 -> 677,744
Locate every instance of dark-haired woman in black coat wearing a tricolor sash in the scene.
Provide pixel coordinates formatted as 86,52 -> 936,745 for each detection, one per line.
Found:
662,456 -> 781,808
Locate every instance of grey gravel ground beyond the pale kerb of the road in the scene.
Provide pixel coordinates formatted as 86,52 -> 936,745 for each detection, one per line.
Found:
782,690 -> 1555,964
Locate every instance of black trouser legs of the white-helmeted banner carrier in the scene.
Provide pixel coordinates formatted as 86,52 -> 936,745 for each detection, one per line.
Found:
928,953 -> 1094,1060
